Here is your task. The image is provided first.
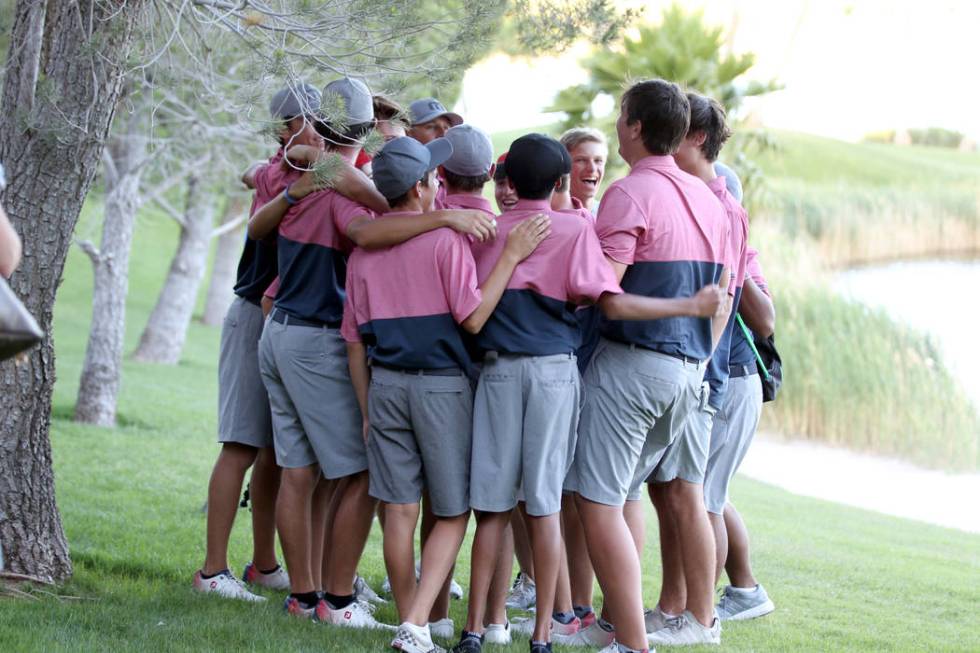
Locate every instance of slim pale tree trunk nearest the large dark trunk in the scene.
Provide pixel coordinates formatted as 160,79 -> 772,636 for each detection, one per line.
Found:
75,132 -> 147,427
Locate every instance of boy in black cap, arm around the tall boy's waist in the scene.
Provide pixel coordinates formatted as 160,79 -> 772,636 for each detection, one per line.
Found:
453,134 -> 721,653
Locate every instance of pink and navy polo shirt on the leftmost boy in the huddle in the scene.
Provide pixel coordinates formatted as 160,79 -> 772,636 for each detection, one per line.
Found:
235,148 -> 300,304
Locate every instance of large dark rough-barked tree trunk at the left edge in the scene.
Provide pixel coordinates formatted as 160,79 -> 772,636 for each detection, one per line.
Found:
0,0 -> 143,580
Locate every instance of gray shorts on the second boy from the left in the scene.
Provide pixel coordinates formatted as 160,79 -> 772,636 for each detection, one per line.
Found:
259,312 -> 367,479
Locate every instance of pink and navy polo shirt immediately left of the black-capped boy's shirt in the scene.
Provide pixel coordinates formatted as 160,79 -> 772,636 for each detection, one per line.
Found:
340,212 -> 481,370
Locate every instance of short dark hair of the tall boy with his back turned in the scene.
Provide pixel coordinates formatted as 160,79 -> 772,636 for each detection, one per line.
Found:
622,79 -> 691,155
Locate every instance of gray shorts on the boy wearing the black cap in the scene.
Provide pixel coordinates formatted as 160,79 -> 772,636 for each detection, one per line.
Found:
470,354 -> 580,517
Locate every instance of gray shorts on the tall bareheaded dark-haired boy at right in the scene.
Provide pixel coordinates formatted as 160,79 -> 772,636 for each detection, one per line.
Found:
566,339 -> 705,506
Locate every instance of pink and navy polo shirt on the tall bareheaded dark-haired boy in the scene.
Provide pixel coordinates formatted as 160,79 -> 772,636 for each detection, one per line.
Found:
596,156 -> 731,360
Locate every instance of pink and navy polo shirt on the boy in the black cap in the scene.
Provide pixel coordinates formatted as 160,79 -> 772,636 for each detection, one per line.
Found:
472,199 -> 623,356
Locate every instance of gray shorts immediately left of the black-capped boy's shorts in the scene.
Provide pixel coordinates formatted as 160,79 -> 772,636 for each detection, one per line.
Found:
367,367 -> 473,517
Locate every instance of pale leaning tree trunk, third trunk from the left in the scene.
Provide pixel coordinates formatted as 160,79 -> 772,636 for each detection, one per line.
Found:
133,172 -> 214,365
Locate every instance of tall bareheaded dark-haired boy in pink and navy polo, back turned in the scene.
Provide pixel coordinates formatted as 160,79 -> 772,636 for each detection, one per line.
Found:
569,80 -> 731,653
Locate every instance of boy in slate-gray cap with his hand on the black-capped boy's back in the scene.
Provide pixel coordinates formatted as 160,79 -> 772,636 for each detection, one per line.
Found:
341,138 -> 548,653
